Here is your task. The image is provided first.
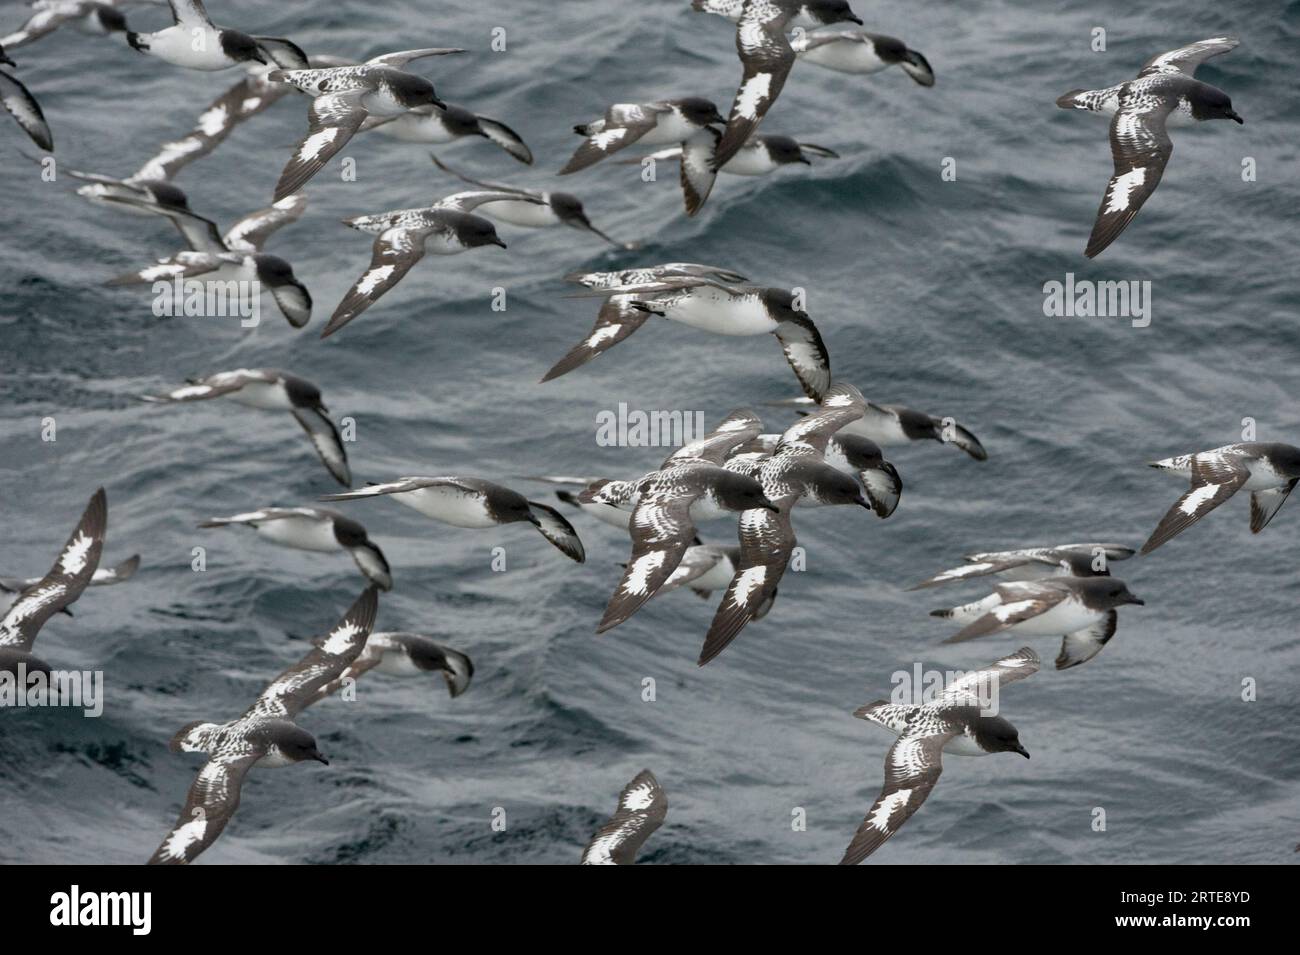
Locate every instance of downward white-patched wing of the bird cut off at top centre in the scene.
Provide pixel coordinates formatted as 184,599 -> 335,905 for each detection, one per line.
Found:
712,0 -> 796,169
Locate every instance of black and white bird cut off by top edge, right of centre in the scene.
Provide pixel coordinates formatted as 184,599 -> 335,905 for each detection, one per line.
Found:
692,0 -> 862,169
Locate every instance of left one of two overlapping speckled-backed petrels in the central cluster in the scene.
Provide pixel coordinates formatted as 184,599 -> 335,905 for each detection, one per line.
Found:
590,418 -> 780,633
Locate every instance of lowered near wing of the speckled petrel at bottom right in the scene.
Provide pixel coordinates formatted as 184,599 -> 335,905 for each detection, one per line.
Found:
840,719 -> 958,865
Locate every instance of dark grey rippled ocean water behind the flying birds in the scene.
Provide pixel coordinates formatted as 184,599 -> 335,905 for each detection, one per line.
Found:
0,0 -> 1300,863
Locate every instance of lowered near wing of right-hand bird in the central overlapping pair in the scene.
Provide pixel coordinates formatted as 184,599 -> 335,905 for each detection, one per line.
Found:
698,507 -> 796,667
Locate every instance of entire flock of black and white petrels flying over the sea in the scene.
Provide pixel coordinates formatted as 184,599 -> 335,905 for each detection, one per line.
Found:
0,0 -> 1268,864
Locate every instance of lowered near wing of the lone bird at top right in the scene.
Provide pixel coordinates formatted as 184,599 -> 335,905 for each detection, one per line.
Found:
1084,87 -> 1174,259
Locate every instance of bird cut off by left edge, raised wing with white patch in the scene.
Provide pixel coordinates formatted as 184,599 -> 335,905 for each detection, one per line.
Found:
0,487 -> 108,676
